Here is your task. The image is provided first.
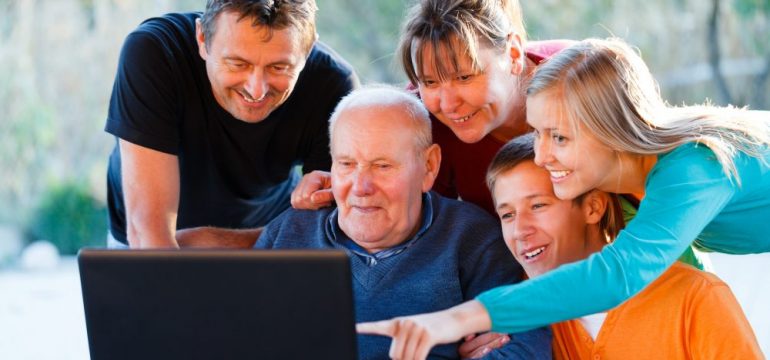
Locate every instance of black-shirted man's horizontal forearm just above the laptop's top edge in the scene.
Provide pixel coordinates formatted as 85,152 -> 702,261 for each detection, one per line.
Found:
176,227 -> 263,249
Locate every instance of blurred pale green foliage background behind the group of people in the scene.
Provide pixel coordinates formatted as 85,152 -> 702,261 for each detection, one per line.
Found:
0,0 -> 770,253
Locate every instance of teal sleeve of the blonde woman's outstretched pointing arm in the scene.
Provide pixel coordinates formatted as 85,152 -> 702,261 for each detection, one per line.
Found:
477,145 -> 735,332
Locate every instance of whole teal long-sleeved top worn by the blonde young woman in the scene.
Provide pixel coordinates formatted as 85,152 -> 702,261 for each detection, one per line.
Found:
477,143 -> 770,333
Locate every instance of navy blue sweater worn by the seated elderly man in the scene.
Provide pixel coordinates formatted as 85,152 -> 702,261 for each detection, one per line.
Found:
255,193 -> 551,360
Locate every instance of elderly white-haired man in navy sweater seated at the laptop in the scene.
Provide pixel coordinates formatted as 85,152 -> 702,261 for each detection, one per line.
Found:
256,87 -> 550,359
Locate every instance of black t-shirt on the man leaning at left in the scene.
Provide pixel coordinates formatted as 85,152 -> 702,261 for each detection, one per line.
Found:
105,13 -> 358,242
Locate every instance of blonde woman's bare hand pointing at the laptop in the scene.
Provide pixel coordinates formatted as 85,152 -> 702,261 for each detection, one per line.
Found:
356,300 -> 491,360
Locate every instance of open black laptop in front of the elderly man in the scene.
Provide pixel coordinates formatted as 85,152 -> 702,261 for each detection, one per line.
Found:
78,249 -> 357,360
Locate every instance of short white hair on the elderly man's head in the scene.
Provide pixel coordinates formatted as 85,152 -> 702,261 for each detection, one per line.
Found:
329,84 -> 433,149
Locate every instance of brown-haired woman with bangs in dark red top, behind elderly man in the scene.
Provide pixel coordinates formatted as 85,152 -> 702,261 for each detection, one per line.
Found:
291,0 -> 571,215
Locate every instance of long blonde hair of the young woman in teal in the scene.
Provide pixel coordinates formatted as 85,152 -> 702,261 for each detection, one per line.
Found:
527,38 -> 770,184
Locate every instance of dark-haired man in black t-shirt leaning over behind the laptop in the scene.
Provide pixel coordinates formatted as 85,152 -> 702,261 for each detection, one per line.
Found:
105,0 -> 358,248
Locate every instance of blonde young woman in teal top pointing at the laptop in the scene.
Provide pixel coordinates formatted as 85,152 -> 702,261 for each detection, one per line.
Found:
359,39 -> 770,359
